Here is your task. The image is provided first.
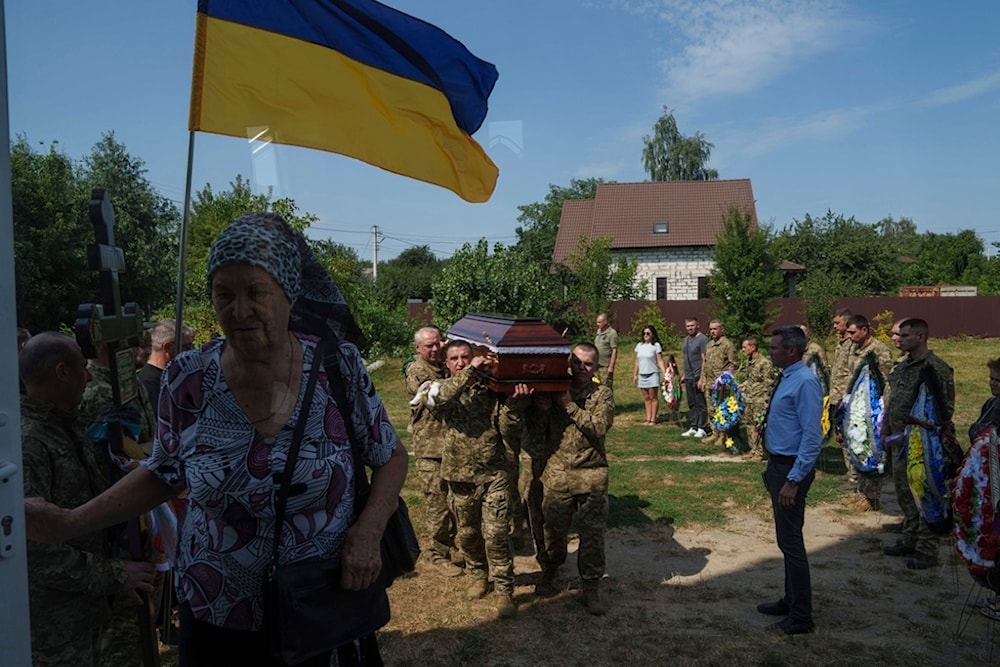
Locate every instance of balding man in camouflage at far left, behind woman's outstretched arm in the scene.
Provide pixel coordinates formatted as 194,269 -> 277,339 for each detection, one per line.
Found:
18,332 -> 153,667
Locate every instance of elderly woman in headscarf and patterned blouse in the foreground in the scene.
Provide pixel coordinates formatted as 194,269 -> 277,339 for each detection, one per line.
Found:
27,214 -> 407,665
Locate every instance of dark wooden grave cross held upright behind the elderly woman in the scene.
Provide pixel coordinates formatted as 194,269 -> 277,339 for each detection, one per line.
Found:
74,189 -> 160,667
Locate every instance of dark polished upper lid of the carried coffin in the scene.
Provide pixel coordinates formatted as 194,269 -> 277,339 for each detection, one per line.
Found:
448,313 -> 570,355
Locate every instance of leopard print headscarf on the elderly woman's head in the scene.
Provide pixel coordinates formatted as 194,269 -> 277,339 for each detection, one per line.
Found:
208,213 -> 364,347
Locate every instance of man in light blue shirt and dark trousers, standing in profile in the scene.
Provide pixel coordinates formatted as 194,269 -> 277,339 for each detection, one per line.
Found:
757,326 -> 823,635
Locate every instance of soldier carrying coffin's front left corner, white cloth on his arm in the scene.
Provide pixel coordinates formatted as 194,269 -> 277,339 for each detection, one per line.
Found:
431,341 -> 516,618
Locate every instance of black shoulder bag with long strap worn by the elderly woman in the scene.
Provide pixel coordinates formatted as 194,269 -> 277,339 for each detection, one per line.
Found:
264,341 -> 390,665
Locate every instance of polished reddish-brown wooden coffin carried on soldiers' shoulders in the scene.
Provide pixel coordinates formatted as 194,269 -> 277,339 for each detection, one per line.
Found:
448,314 -> 570,393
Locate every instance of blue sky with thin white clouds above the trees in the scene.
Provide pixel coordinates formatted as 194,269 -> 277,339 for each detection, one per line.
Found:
5,0 -> 1000,258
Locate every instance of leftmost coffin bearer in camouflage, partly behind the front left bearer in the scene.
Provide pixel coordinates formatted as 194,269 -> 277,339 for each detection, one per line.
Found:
406,327 -> 462,577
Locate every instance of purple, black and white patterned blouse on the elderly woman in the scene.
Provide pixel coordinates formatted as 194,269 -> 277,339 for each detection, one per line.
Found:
146,334 -> 399,630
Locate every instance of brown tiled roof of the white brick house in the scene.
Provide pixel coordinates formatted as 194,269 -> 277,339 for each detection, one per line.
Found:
553,178 -> 757,262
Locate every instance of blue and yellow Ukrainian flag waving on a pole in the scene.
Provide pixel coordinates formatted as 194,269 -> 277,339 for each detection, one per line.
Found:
189,0 -> 498,202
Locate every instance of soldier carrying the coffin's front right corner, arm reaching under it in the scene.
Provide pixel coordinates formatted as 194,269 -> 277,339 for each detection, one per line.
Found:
508,343 -> 615,615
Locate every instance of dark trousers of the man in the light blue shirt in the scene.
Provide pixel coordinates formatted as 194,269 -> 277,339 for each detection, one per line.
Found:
763,459 -> 816,623
